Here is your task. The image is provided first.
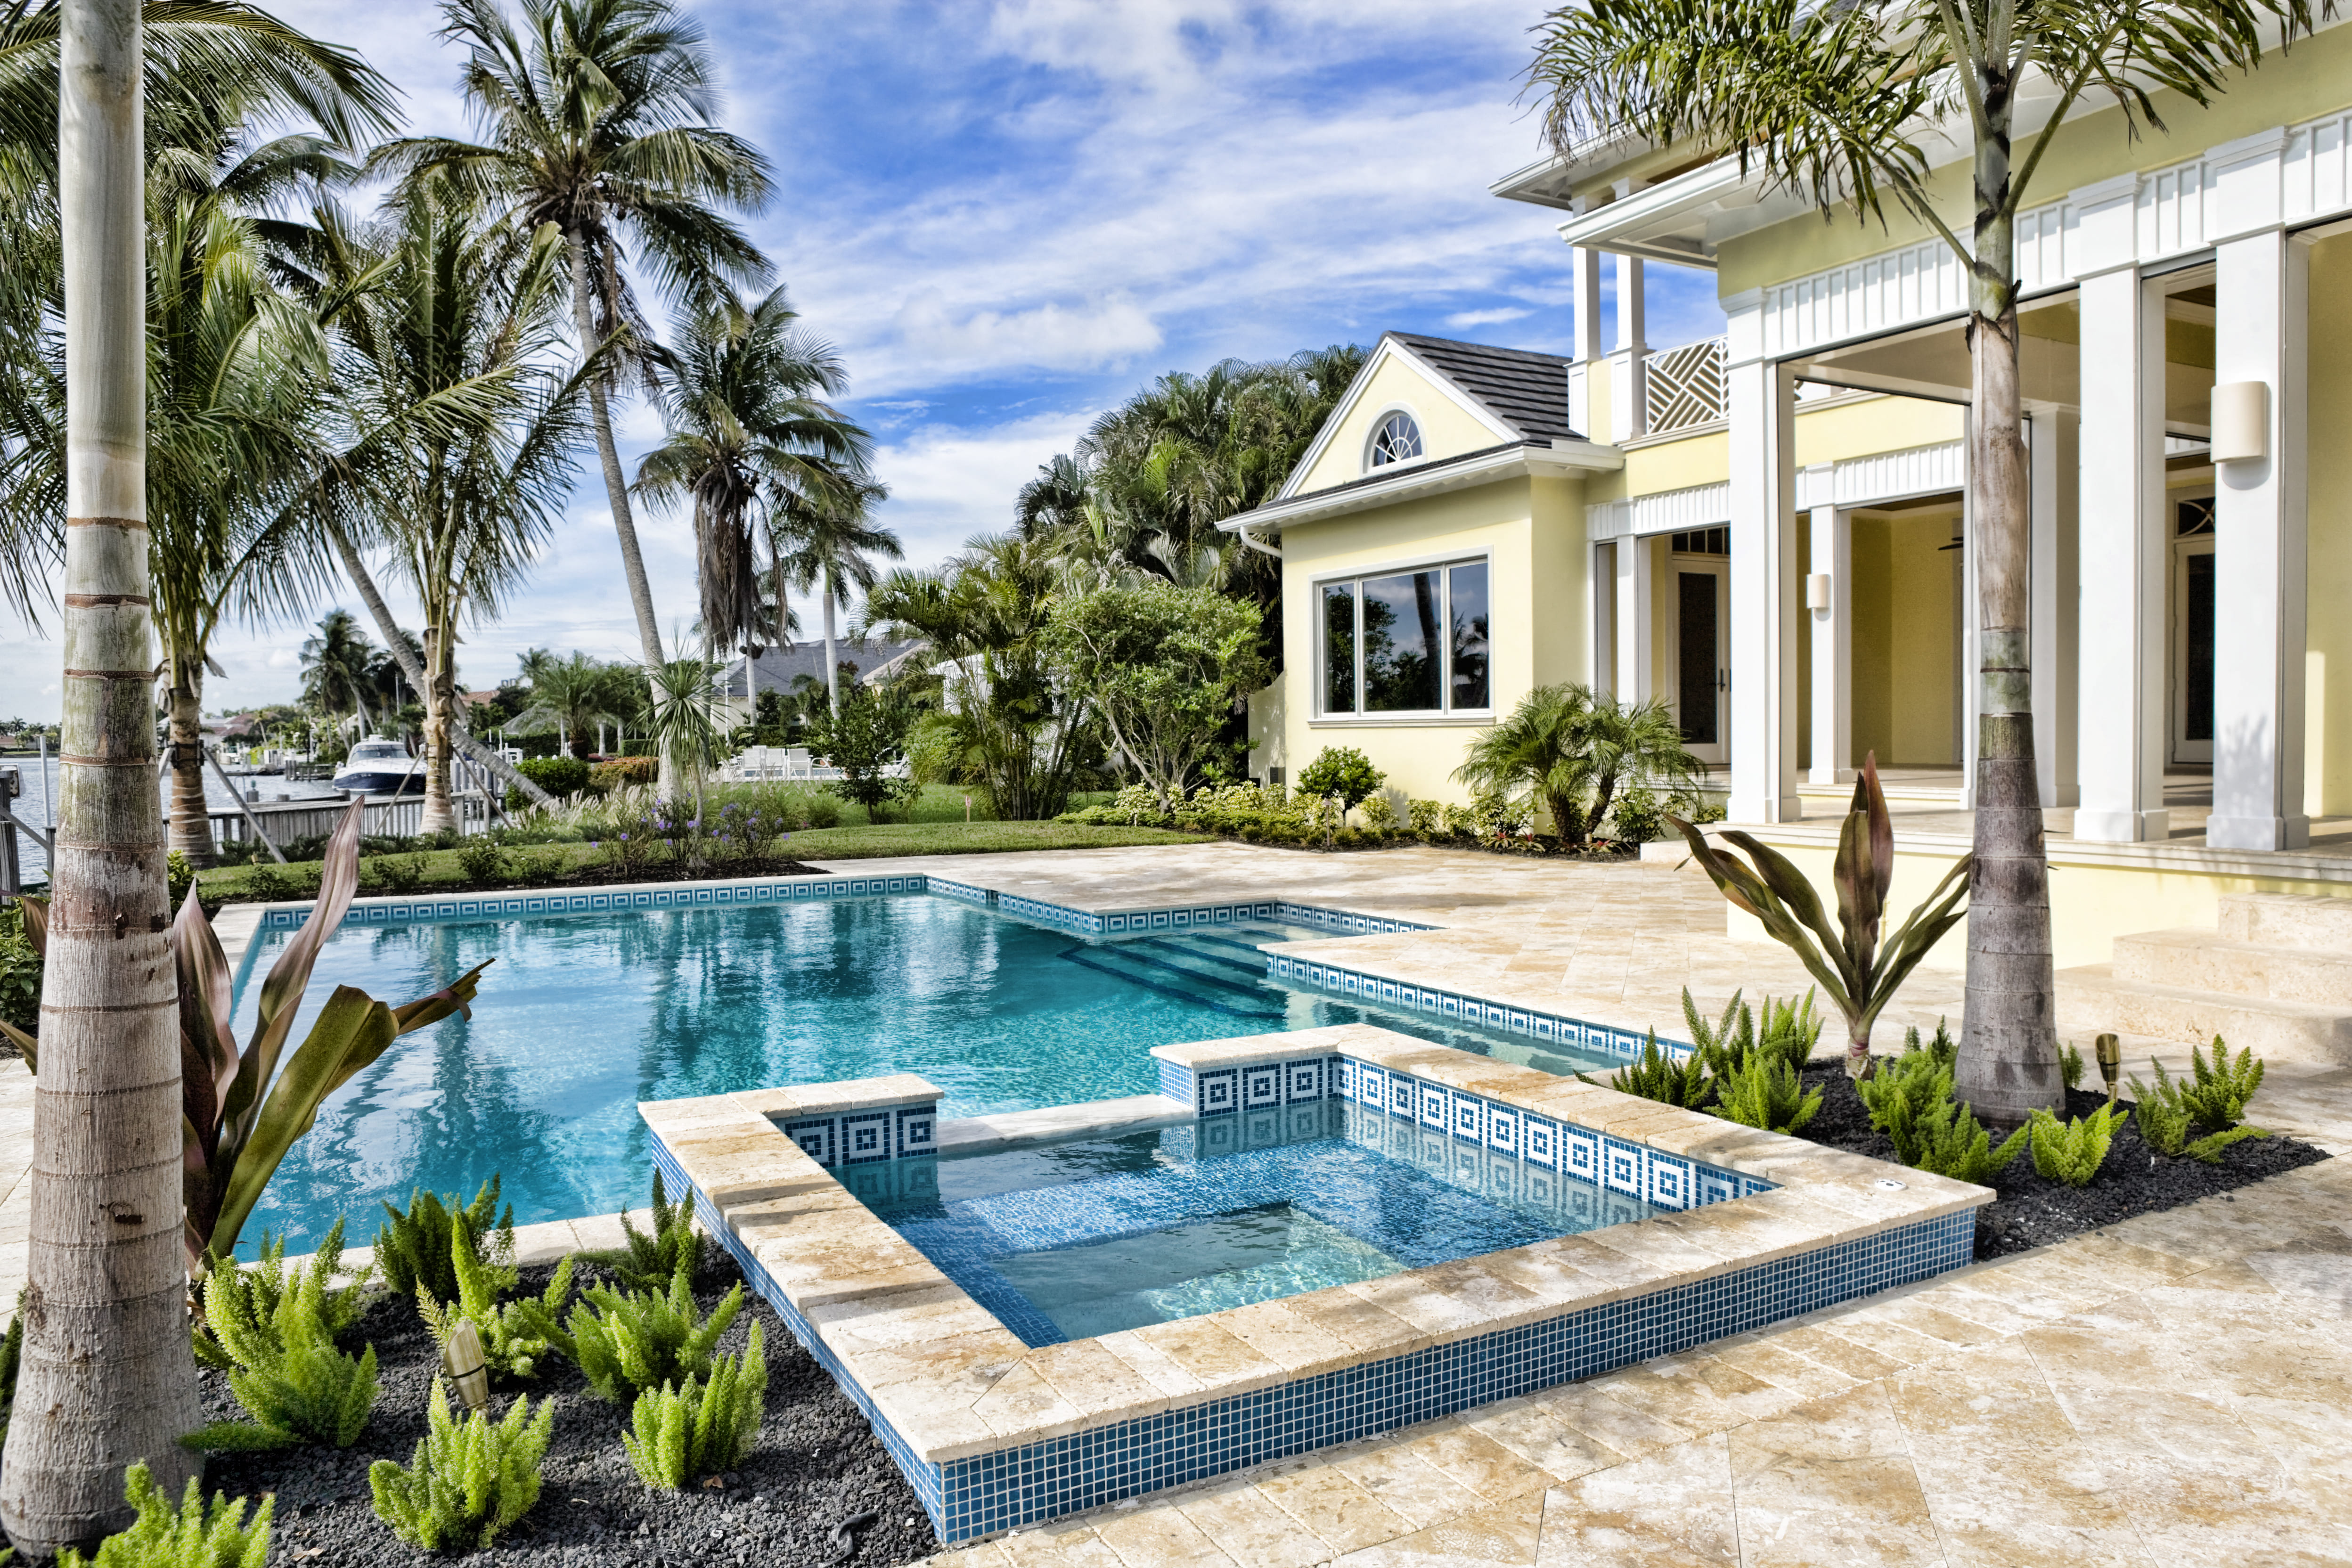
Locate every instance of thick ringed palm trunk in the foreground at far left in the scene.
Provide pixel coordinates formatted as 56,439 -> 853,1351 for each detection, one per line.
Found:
0,0 -> 202,1556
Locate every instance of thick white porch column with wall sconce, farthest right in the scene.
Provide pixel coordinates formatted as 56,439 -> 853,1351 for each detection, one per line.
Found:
2206,222 -> 2312,849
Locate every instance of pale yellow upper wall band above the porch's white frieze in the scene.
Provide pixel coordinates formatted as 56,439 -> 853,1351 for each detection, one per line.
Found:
1712,26 -> 2352,296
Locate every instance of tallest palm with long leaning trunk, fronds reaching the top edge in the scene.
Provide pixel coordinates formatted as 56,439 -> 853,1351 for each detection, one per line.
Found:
379,0 -> 769,766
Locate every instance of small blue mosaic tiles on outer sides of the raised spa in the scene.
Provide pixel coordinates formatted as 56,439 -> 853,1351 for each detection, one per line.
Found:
672,1110 -> 1976,1544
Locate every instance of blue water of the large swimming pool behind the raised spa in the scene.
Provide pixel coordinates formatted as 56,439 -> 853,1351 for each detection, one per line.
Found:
237,896 -> 1597,1250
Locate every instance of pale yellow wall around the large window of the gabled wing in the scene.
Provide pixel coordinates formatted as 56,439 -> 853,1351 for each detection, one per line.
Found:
1251,477 -> 1590,801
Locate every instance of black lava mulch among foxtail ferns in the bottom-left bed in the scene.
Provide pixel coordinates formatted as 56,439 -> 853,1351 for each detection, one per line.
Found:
202,1258 -> 939,1568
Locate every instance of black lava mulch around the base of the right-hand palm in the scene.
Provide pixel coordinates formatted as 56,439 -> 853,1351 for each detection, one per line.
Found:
1797,1062 -> 2328,1260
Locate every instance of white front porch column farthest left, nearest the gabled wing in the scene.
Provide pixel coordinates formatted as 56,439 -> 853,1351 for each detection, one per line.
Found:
1724,294 -> 1802,823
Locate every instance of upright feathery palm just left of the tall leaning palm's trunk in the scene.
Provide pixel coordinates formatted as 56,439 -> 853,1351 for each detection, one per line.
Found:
322,176 -> 581,832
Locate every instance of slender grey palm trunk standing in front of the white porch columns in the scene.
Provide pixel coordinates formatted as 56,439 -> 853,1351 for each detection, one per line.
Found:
1954,98 -> 2065,1126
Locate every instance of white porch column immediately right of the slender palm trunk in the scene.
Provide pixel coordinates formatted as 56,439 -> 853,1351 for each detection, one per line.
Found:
2074,258 -> 2169,844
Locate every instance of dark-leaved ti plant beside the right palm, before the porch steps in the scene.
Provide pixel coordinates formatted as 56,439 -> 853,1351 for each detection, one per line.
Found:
1667,752 -> 1973,1079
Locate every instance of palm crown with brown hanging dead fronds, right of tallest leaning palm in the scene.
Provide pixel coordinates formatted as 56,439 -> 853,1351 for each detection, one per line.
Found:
637,287 -> 875,700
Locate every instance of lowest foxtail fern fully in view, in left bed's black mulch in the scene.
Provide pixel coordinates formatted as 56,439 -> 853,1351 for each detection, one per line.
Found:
367,1378 -> 555,1568
